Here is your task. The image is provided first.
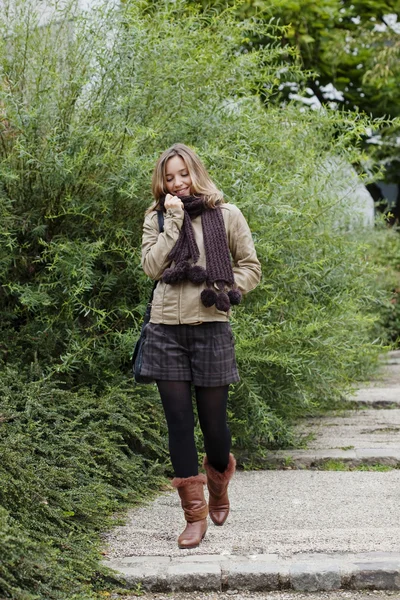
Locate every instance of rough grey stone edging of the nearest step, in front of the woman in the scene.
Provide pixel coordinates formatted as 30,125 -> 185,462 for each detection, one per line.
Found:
106,552 -> 400,593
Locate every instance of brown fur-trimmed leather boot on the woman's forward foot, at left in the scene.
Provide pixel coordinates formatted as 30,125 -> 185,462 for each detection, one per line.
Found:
172,474 -> 208,548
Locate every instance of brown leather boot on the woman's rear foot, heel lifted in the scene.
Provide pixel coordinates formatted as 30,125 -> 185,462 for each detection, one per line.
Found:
203,454 -> 236,525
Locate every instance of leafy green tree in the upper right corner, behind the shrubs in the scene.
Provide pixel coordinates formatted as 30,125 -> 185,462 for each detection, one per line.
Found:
193,0 -> 400,222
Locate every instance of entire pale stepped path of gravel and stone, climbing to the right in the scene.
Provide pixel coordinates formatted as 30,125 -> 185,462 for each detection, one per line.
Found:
106,351 -> 400,592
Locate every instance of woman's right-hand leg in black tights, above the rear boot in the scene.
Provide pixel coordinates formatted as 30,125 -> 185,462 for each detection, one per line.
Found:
195,385 -> 231,473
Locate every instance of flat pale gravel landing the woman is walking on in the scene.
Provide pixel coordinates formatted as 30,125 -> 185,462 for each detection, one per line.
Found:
102,470 -> 400,558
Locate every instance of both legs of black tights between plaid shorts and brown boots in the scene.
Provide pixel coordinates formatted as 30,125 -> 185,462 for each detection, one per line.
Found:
157,381 -> 231,477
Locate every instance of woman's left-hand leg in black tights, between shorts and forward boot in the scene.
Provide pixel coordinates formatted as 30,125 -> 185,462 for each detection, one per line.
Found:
157,381 -> 199,477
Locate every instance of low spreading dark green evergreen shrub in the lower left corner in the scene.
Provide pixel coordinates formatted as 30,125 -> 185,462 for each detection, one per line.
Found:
0,370 -> 167,600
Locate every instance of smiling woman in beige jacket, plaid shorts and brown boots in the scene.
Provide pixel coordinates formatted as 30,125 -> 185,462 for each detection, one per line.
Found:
141,144 -> 261,548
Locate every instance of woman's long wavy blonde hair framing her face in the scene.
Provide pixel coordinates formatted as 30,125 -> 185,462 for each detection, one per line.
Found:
146,144 -> 224,214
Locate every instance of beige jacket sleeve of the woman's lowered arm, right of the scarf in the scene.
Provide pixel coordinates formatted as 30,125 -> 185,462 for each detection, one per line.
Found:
230,208 -> 261,294
